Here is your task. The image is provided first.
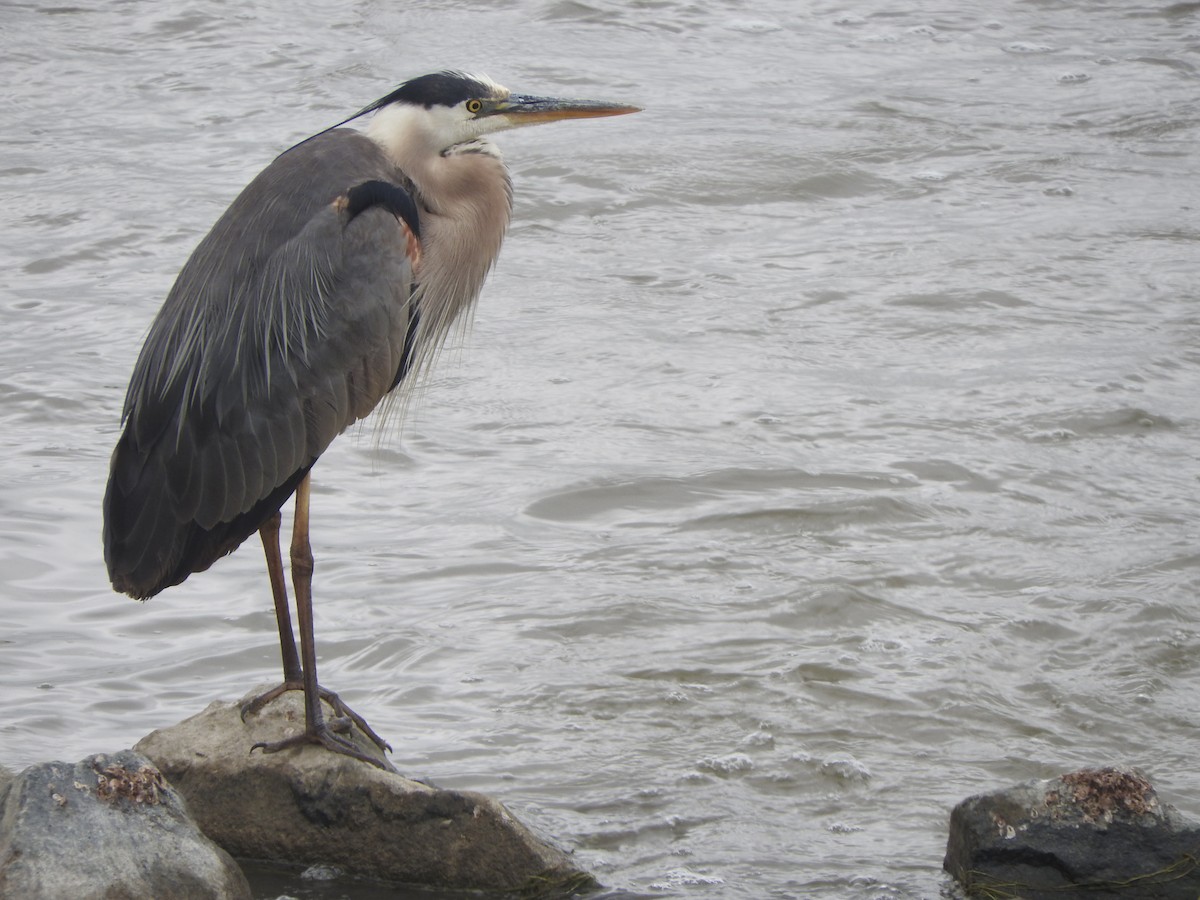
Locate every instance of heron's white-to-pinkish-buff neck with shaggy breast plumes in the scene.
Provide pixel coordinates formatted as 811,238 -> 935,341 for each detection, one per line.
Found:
367,107 -> 512,379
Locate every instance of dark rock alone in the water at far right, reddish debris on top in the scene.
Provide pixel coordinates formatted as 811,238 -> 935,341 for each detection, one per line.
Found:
944,768 -> 1200,900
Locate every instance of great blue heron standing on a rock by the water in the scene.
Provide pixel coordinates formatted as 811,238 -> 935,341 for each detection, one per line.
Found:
104,72 -> 637,766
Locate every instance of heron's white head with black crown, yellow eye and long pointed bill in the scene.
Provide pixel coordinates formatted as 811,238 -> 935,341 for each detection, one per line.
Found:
360,72 -> 638,160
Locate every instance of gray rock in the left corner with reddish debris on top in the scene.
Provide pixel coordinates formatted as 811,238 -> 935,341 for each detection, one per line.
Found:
0,750 -> 250,900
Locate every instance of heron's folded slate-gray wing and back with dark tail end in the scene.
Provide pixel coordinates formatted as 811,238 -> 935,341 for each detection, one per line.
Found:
104,130 -> 419,598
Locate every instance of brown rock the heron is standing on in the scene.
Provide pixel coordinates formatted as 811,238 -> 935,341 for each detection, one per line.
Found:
137,691 -> 594,894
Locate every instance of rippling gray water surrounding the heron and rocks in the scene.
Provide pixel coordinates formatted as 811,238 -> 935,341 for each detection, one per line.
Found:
0,0 -> 1200,900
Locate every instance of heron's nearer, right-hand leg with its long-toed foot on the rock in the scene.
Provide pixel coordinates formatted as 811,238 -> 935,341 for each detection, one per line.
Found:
251,475 -> 391,769
